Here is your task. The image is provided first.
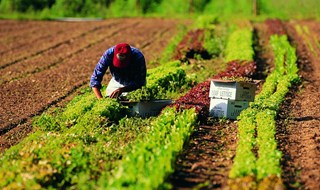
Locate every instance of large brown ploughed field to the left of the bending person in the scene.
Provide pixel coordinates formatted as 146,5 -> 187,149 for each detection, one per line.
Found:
0,19 -> 186,145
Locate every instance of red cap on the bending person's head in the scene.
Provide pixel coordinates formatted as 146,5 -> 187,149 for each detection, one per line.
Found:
113,43 -> 131,69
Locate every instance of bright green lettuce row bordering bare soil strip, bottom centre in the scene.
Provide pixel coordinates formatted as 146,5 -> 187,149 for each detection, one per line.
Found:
99,108 -> 197,189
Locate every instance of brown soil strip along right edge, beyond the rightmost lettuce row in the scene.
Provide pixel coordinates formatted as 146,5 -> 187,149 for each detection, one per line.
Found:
277,21 -> 320,190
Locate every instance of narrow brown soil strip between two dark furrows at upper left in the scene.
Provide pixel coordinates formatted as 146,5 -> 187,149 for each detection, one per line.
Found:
0,20 -> 137,84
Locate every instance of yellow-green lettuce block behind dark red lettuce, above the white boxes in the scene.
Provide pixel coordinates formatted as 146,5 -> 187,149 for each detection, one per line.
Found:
225,28 -> 254,62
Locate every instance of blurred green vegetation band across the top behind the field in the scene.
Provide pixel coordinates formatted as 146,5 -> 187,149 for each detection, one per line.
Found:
0,0 -> 320,19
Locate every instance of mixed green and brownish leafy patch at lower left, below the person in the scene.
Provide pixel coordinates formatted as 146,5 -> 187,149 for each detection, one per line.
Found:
0,97 -> 151,189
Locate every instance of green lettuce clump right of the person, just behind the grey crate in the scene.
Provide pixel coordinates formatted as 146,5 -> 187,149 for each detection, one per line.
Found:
126,61 -> 192,101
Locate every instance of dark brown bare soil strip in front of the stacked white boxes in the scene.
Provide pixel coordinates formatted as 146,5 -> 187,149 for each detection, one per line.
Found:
169,121 -> 237,189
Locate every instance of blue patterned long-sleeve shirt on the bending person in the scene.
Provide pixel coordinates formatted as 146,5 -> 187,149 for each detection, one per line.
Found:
90,46 -> 147,89
